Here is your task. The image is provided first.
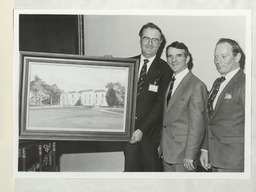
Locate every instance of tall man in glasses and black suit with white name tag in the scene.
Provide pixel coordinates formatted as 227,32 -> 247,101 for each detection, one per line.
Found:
124,23 -> 172,172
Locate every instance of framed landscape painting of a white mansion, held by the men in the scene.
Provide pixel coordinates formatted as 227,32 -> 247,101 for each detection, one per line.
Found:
19,52 -> 138,141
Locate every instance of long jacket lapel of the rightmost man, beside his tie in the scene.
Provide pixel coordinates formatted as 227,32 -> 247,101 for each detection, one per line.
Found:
211,69 -> 243,118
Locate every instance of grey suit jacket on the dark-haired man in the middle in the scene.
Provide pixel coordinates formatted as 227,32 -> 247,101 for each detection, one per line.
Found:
161,71 -> 207,164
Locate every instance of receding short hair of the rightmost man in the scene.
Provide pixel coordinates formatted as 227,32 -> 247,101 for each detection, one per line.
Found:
216,38 -> 245,69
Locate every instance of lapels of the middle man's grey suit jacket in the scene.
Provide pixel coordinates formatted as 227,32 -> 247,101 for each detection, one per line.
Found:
165,71 -> 193,118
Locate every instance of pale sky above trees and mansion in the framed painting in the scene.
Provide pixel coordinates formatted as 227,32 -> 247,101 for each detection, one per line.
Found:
29,62 -> 128,92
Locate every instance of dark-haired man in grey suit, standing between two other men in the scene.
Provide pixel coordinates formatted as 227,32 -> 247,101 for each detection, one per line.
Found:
160,41 -> 207,172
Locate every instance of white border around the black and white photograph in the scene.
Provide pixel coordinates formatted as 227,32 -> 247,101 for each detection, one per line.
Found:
13,9 -> 252,179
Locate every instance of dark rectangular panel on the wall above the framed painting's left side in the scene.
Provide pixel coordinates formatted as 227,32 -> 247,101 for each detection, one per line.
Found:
19,15 -> 79,54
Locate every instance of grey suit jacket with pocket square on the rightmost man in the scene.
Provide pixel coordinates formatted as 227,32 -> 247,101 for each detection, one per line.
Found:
202,69 -> 245,169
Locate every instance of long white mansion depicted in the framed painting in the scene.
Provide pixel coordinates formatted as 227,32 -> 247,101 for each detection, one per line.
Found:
60,89 -> 108,106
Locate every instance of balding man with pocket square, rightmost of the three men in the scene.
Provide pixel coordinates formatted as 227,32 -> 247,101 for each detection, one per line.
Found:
200,39 -> 245,172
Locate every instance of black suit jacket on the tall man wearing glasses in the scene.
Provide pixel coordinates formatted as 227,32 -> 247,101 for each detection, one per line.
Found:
135,56 -> 172,143
